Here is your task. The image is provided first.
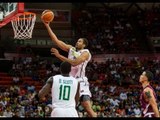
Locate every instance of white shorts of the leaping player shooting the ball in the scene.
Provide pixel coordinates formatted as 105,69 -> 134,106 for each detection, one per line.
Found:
76,77 -> 92,97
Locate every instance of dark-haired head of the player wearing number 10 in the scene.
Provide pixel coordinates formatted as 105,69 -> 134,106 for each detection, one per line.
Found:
60,61 -> 71,74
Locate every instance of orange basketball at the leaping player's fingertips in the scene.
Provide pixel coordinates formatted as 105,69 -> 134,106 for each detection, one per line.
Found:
41,10 -> 54,22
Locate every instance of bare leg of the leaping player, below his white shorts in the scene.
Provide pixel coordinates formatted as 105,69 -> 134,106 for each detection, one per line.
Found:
80,95 -> 97,117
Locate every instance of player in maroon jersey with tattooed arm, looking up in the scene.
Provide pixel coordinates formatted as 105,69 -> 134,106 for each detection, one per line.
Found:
139,71 -> 160,117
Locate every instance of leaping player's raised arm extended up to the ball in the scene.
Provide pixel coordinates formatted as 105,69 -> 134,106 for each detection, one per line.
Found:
41,18 -> 72,52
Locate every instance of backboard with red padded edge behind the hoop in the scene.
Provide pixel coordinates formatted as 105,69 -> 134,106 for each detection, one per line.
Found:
0,2 -> 24,28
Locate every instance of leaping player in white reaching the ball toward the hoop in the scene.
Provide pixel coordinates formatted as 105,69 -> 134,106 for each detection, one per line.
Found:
42,19 -> 97,117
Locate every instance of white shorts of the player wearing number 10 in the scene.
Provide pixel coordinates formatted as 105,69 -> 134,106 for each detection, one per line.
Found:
51,108 -> 79,117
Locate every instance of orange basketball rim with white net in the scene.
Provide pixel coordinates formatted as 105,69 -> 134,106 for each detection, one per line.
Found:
11,12 -> 36,39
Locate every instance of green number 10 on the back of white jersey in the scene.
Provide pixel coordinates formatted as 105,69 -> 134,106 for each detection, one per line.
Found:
59,85 -> 71,100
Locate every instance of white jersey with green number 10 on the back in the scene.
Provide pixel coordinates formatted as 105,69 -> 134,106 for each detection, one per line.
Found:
51,75 -> 78,109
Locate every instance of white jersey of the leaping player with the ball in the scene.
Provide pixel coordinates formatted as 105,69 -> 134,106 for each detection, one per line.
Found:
68,47 -> 91,78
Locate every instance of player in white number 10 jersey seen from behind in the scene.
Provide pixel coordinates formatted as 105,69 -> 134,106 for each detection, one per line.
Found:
38,62 -> 80,117
